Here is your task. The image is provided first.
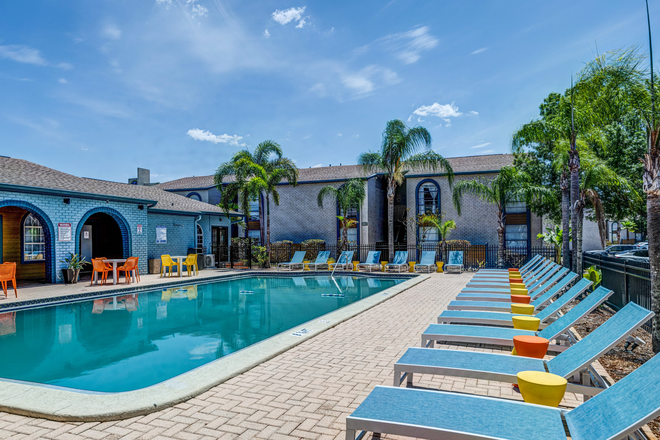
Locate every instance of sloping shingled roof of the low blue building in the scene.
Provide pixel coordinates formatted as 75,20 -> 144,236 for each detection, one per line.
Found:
0,157 -> 240,215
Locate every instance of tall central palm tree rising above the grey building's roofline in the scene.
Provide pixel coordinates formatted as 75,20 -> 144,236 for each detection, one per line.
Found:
358,119 -> 454,261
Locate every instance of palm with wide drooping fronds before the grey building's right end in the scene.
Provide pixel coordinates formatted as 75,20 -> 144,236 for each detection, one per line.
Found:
452,166 -> 553,268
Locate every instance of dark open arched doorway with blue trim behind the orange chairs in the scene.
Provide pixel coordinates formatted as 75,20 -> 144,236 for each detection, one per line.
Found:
76,208 -> 131,262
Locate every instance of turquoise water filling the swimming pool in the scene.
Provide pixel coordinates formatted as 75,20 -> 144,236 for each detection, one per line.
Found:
0,276 -> 404,392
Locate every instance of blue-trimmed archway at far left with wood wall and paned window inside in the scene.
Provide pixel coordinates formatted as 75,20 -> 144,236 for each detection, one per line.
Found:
0,200 -> 56,283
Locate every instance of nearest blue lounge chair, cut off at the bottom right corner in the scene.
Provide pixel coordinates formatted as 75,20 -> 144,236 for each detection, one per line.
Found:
346,350 -> 660,440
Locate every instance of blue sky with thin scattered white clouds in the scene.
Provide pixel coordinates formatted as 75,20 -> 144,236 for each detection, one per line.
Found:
0,0 -> 660,181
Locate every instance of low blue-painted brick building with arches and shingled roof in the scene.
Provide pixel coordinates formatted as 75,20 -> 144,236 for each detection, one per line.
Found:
0,157 -> 240,283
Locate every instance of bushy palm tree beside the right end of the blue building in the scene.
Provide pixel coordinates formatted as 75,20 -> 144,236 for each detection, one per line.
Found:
214,140 -> 298,255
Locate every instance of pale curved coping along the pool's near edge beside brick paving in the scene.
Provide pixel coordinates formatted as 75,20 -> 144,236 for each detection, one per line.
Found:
0,274 -> 430,422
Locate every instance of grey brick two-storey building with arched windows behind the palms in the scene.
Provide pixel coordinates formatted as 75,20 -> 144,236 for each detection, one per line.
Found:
157,154 -> 542,251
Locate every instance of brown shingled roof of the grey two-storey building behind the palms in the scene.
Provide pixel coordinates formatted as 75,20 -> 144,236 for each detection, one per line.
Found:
156,154 -> 513,191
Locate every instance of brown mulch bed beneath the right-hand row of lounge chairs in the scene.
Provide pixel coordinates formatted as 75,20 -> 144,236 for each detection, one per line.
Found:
574,305 -> 660,438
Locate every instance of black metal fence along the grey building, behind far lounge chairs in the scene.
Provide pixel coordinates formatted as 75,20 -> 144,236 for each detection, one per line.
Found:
213,243 -> 559,270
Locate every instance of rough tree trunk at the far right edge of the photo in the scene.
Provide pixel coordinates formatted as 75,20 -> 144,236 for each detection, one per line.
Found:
643,136 -> 660,353
